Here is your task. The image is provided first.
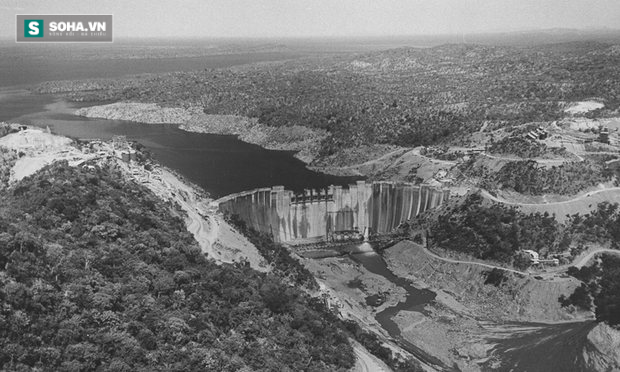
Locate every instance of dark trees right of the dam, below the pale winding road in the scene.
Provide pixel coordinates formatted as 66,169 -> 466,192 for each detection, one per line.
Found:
424,198 -> 620,325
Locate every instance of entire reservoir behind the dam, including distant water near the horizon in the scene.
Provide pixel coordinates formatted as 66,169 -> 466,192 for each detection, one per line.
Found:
0,39 -> 359,197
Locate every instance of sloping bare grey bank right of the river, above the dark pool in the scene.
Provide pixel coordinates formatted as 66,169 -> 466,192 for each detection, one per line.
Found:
385,242 -> 589,322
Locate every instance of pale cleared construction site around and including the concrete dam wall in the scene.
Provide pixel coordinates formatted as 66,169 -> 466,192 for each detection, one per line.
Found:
0,99 -> 620,370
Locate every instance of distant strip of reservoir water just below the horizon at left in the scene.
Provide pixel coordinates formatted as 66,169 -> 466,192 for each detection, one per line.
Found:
0,40 -> 300,87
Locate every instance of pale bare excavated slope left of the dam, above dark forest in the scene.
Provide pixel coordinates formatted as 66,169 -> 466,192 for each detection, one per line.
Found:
0,126 -> 270,272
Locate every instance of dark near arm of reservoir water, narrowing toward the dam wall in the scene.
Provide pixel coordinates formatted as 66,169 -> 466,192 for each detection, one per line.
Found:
0,90 -> 360,197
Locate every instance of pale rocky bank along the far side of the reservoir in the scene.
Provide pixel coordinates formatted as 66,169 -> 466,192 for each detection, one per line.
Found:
75,102 -> 328,163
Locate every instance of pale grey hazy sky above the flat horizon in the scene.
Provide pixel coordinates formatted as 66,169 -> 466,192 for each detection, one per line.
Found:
0,0 -> 620,39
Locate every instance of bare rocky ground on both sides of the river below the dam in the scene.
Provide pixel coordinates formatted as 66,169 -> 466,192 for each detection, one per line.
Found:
304,241 -> 591,371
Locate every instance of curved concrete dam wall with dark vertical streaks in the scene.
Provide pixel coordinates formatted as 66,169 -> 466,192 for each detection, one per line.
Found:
216,181 -> 450,242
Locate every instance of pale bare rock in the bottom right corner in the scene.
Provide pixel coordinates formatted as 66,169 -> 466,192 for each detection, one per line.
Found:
583,323 -> 620,372
